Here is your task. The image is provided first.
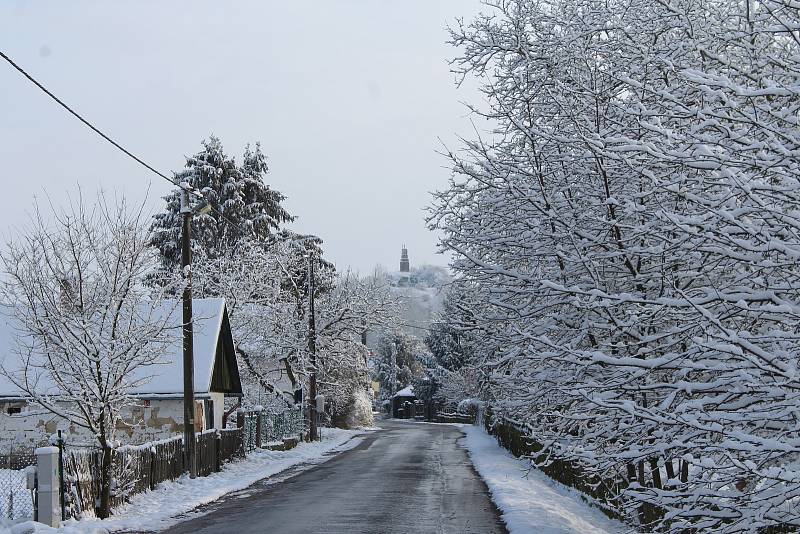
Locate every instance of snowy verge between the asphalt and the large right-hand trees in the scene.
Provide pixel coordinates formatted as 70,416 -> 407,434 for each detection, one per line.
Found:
459,425 -> 630,534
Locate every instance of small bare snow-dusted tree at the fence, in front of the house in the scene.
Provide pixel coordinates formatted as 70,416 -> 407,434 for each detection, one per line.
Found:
0,196 -> 179,517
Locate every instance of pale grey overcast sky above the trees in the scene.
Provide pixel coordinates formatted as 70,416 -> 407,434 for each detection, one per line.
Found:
0,0 -> 480,272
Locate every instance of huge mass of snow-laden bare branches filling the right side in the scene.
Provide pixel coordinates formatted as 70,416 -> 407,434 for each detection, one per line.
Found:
430,0 -> 800,532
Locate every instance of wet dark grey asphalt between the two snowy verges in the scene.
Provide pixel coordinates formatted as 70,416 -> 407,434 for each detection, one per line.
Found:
157,421 -> 507,534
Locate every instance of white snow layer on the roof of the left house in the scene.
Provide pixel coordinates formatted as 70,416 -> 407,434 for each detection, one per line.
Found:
0,299 -> 231,398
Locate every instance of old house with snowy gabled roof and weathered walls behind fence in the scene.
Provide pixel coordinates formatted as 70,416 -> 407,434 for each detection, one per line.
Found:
0,299 -> 242,452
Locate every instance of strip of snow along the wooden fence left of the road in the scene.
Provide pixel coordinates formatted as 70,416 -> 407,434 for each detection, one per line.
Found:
0,428 -> 366,534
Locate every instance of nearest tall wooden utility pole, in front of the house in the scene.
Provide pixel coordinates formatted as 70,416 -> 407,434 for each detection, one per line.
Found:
181,188 -> 197,478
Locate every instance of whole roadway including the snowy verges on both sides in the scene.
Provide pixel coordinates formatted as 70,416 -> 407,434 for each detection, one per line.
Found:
6,421 -> 627,534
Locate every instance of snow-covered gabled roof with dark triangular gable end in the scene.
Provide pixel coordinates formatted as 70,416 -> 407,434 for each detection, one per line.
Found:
0,299 -> 242,398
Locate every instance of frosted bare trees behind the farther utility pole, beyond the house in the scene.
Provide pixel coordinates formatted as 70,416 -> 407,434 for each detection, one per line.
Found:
193,236 -> 396,423
